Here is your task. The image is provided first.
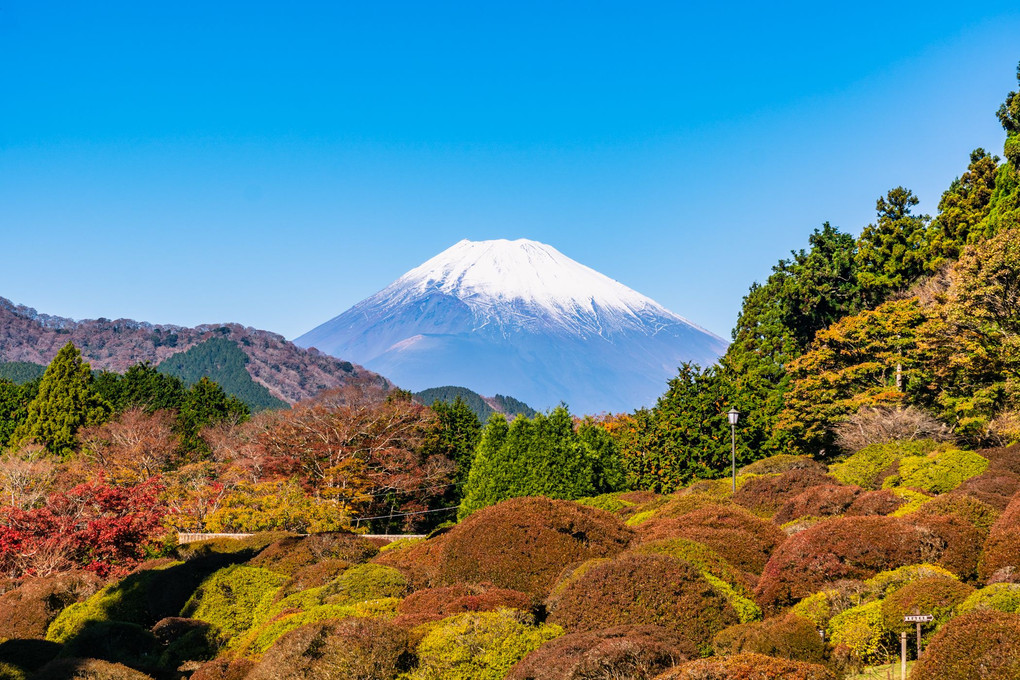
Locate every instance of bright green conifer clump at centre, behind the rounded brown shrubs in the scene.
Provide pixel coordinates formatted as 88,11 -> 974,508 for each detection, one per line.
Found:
459,406 -> 623,518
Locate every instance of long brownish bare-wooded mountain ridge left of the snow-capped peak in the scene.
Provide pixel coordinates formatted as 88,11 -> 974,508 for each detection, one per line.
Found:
0,298 -> 391,404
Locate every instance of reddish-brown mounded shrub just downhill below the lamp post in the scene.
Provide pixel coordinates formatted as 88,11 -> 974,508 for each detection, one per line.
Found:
638,505 -> 786,574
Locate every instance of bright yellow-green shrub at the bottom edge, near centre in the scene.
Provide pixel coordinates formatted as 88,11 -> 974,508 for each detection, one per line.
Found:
406,610 -> 563,680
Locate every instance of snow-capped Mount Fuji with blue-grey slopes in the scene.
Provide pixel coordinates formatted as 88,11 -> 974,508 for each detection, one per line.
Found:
294,239 -> 726,414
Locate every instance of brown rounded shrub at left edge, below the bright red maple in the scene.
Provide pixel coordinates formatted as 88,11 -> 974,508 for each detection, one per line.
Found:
0,571 -> 102,639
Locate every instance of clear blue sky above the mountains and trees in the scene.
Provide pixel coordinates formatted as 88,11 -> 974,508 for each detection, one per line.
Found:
0,0 -> 1020,337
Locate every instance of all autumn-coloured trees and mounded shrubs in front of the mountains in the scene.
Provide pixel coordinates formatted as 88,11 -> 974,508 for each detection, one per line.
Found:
0,63 -> 1020,680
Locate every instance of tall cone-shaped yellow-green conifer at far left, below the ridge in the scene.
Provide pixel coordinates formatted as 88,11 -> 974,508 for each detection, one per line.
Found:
11,343 -> 112,455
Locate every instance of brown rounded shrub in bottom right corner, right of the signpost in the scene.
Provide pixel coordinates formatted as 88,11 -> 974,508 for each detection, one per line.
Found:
910,610 -> 1020,680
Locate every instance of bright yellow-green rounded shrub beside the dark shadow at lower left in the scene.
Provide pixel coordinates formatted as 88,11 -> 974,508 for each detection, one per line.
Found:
181,566 -> 287,639
